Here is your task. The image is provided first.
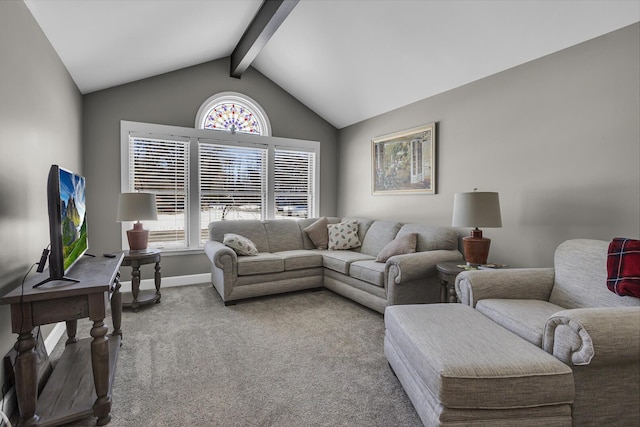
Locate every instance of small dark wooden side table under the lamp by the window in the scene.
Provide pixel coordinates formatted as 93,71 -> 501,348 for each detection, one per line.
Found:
122,249 -> 162,311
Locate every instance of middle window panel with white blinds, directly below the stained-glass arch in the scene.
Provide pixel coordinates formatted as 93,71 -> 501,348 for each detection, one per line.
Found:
198,141 -> 267,243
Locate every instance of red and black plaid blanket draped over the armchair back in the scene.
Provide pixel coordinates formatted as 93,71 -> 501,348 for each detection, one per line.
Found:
607,237 -> 640,298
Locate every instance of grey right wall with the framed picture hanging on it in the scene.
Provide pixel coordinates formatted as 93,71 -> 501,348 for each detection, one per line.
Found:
338,24 -> 640,267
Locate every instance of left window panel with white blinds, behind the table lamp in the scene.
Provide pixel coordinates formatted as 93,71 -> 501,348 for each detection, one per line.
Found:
129,136 -> 189,249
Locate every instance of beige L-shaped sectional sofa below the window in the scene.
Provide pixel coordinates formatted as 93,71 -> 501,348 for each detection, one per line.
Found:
205,218 -> 462,313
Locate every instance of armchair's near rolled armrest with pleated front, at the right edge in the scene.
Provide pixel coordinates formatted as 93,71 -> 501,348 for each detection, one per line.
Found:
542,307 -> 640,366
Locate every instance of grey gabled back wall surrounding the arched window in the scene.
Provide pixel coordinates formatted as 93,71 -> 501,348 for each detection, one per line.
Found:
83,58 -> 337,278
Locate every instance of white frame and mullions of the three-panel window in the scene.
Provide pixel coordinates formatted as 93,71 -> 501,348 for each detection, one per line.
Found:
120,120 -> 321,253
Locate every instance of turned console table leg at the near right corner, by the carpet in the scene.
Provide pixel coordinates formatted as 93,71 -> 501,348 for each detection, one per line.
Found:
91,319 -> 111,426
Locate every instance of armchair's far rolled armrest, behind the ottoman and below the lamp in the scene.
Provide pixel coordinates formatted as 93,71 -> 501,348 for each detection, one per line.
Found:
455,268 -> 554,307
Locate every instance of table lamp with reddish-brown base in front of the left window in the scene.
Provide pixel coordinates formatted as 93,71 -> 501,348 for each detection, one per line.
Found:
117,193 -> 158,251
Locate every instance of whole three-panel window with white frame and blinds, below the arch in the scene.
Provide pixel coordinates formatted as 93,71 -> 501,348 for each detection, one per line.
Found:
121,121 -> 320,253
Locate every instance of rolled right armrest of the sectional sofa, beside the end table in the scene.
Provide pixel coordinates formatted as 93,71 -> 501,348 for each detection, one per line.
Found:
385,249 -> 462,284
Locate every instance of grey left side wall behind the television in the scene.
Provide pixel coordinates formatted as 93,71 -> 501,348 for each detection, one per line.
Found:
0,1 -> 83,384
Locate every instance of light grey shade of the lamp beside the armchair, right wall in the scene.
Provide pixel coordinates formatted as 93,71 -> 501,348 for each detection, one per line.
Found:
451,191 -> 502,228
